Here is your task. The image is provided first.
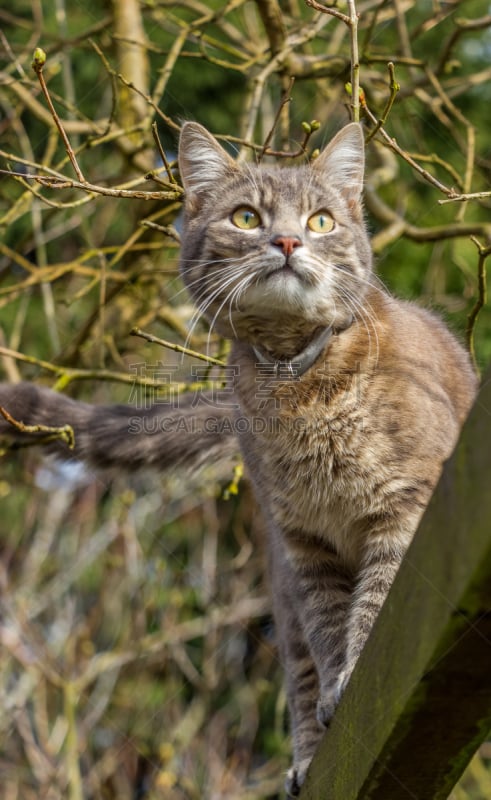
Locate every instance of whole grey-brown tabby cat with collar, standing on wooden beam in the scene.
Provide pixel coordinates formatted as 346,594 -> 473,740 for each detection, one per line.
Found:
0,122 -> 476,796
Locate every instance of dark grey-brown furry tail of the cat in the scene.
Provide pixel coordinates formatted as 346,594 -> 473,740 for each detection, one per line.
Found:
0,383 -> 238,470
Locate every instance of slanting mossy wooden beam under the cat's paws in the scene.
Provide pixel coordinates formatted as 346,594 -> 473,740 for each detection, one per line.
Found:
300,370 -> 491,800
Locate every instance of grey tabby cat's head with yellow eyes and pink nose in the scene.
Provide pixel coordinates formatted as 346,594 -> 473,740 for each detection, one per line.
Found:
179,122 -> 371,350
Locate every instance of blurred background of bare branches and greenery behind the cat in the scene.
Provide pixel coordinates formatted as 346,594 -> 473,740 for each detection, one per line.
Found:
0,0 -> 491,800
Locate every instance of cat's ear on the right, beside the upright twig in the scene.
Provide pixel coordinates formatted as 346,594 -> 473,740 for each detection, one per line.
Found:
312,122 -> 365,207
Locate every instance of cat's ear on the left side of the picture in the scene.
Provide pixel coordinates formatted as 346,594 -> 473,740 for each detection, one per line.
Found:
179,122 -> 237,205
